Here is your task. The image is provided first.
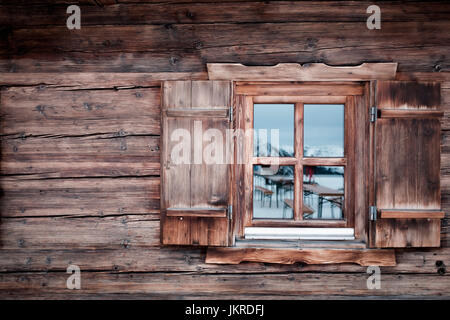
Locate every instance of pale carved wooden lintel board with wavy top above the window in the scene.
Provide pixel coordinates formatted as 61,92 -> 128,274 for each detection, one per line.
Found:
206,62 -> 397,81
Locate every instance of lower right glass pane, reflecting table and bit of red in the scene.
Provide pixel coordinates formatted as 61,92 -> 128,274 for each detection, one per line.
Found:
303,166 -> 344,220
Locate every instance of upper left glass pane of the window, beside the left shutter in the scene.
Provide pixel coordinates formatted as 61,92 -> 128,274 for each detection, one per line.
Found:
253,104 -> 294,157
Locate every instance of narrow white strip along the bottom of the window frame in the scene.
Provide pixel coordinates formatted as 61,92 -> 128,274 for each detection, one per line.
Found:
245,227 -> 355,240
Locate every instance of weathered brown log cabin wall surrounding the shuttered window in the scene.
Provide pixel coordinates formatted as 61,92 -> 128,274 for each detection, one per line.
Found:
0,0 -> 450,299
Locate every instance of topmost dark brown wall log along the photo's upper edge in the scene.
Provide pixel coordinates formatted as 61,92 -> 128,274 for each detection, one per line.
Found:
0,0 -> 448,27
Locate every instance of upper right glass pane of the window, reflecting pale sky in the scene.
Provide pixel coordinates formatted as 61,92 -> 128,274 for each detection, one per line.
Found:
303,104 -> 344,157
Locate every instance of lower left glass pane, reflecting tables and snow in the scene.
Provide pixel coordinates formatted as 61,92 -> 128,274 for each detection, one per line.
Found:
253,165 -> 294,219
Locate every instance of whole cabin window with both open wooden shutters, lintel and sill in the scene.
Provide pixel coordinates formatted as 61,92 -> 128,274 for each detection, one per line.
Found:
161,64 -> 444,265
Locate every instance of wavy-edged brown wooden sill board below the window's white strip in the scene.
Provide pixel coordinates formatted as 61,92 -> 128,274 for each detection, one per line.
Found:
205,240 -> 396,266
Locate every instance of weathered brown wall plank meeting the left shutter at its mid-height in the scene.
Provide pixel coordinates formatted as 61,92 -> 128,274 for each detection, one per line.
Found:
0,134 -> 160,179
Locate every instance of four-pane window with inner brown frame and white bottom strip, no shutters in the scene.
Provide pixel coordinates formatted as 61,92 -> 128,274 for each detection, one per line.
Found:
241,84 -> 356,240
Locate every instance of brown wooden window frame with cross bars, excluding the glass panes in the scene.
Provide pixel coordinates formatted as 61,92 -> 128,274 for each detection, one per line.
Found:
233,81 -> 369,240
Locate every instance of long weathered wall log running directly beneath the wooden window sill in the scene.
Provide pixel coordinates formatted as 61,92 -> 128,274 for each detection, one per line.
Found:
0,246 -> 450,276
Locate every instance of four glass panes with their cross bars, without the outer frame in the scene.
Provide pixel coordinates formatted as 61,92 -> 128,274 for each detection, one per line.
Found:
253,101 -> 350,221
